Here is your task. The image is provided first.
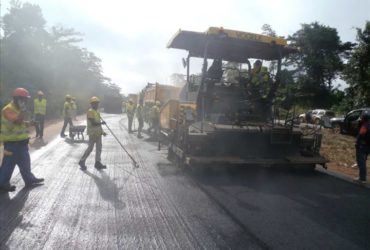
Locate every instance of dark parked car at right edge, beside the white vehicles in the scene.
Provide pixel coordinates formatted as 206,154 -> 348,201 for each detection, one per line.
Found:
330,108 -> 370,135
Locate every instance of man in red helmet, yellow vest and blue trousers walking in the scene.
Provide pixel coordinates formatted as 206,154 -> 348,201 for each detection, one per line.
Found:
0,88 -> 44,192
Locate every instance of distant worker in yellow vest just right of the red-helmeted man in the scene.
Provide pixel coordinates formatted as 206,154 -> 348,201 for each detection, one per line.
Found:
33,90 -> 47,139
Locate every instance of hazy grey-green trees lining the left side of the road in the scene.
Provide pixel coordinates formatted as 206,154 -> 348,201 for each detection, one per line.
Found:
0,1 -> 120,117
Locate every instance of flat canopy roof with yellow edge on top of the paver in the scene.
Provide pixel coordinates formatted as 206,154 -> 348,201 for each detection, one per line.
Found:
167,27 -> 296,63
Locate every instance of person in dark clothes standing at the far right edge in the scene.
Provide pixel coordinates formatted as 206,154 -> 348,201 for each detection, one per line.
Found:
354,112 -> 370,183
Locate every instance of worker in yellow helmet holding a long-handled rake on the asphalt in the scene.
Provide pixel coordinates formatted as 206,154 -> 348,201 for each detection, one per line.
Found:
78,96 -> 107,170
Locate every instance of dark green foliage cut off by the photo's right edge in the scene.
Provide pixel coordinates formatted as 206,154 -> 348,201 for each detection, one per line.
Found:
343,21 -> 370,108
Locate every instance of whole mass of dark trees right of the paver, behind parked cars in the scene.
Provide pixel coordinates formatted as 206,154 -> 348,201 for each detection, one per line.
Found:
270,22 -> 370,113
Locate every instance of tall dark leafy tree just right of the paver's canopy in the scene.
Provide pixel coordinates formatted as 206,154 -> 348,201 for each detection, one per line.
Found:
286,22 -> 353,108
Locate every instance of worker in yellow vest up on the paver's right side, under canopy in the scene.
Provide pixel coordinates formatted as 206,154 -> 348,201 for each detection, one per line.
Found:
250,60 -> 271,100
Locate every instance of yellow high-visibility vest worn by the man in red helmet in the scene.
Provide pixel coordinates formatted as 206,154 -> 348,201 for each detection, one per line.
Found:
0,102 -> 29,142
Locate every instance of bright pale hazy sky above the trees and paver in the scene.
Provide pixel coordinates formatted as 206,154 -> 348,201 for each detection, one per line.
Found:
1,0 -> 370,94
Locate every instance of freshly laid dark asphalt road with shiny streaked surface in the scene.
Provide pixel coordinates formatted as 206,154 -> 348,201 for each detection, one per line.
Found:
0,115 -> 370,250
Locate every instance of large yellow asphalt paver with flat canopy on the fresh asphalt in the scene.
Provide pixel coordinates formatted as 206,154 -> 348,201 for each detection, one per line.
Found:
160,27 -> 326,169
